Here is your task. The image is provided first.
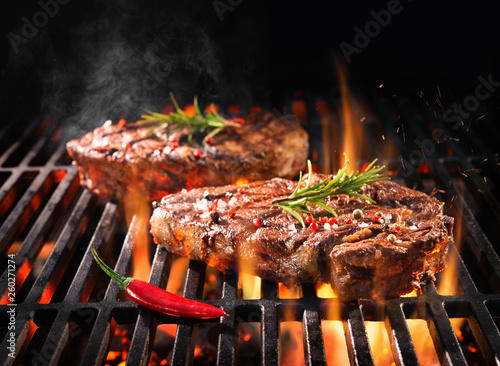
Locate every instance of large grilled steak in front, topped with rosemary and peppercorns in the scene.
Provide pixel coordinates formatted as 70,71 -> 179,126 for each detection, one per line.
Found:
151,175 -> 453,301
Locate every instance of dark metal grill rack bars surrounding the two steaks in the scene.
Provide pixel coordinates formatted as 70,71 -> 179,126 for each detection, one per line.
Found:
0,89 -> 500,365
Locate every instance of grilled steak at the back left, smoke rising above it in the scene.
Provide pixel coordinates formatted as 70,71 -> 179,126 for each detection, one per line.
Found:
67,113 -> 309,200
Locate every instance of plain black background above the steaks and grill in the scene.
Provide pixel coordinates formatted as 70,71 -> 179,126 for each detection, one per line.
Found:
1,0 -> 500,123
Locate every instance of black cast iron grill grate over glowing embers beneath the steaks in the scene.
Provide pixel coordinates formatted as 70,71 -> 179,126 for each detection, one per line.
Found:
0,89 -> 500,365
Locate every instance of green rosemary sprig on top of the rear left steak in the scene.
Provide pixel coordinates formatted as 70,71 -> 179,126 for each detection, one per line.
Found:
138,93 -> 241,141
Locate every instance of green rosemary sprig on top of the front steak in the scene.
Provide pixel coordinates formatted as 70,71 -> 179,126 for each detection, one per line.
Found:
272,153 -> 388,227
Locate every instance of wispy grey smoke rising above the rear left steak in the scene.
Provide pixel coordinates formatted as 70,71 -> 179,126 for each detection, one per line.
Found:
2,0 -> 266,139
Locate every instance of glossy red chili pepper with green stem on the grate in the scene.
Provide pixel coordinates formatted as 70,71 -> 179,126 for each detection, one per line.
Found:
90,243 -> 227,319
